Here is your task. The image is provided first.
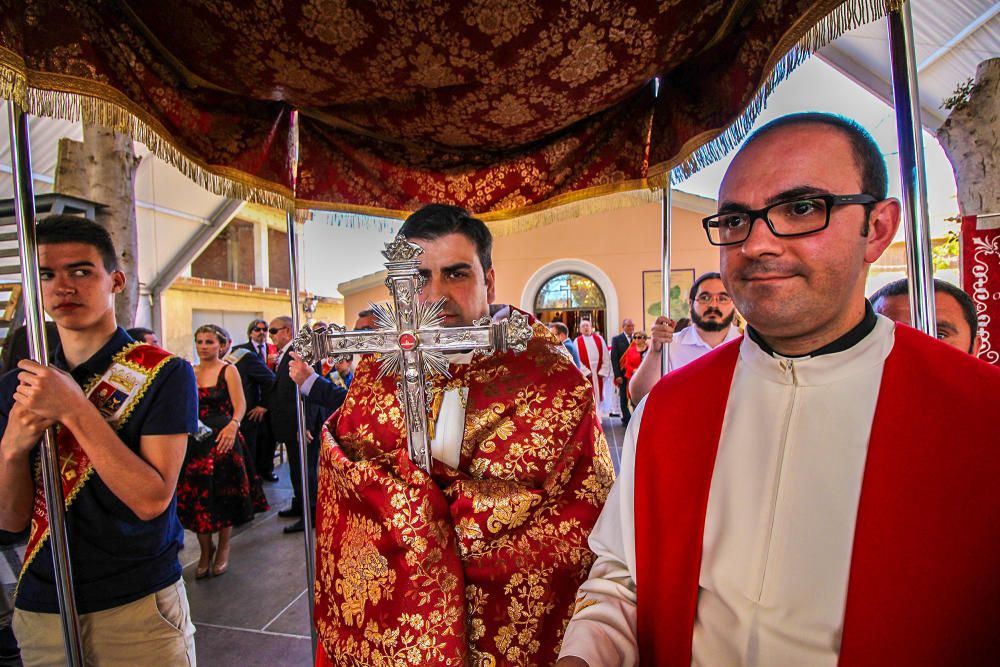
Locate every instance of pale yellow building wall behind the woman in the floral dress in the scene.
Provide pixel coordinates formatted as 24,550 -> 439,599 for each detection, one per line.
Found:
161,280 -> 346,360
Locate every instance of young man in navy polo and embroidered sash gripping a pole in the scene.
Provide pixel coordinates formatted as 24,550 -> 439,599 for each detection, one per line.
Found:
0,216 -> 198,667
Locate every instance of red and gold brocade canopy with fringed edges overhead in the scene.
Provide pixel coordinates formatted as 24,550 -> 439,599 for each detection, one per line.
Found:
0,0 -> 898,219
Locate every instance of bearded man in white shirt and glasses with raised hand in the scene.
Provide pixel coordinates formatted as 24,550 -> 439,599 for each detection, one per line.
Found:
629,271 -> 740,405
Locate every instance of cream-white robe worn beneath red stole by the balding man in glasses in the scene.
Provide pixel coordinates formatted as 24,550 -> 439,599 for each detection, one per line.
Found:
561,316 -> 894,667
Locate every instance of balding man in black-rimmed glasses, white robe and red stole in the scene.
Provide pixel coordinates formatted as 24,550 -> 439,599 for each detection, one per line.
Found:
562,114 -> 1000,667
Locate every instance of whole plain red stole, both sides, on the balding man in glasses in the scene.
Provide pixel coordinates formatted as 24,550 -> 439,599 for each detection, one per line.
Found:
635,325 -> 1000,667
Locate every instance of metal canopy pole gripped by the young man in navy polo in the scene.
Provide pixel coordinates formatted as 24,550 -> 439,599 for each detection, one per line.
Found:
7,102 -> 83,667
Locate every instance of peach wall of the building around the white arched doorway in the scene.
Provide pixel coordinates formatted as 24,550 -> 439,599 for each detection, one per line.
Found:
341,203 -> 719,335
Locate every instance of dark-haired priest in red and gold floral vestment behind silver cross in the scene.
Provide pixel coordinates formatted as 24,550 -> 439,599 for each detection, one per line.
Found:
315,205 -> 614,666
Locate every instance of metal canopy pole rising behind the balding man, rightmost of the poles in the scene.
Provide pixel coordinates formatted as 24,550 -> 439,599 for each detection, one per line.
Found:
886,2 -> 937,336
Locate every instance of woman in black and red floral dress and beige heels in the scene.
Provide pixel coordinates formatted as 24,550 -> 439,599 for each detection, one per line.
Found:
177,325 -> 267,579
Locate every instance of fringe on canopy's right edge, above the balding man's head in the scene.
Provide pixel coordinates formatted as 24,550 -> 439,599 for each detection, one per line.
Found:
649,0 -> 905,188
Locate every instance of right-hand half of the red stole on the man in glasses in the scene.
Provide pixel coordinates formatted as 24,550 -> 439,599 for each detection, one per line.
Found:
840,324 -> 1000,667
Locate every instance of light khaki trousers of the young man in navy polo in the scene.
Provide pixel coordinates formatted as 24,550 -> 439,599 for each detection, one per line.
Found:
14,579 -> 196,667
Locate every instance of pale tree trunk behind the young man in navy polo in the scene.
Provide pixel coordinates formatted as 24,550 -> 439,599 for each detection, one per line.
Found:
55,123 -> 141,328
